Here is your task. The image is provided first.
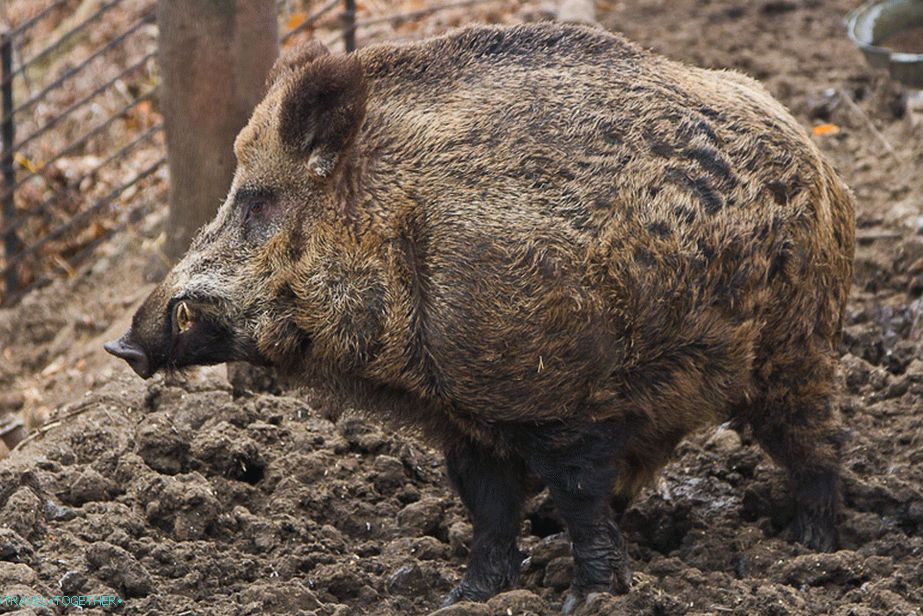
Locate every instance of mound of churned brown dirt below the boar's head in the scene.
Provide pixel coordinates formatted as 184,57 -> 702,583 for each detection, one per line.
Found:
0,377 -> 462,614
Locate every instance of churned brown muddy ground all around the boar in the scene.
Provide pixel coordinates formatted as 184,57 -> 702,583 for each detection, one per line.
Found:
0,0 -> 923,616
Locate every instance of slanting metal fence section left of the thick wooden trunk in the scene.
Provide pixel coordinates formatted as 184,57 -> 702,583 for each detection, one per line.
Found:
0,0 -> 166,304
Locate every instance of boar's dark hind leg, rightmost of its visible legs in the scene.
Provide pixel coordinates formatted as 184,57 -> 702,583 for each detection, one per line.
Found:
750,360 -> 843,552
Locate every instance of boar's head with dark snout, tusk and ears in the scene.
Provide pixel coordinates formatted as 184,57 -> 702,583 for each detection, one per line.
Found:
106,43 -> 384,378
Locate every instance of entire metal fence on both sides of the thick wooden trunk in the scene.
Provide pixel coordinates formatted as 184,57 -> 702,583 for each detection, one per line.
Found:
0,0 -> 491,304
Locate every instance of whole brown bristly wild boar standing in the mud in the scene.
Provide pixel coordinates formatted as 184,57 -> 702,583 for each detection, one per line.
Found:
107,24 -> 855,611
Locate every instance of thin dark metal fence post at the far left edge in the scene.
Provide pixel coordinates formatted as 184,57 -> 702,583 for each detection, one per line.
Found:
0,30 -> 19,298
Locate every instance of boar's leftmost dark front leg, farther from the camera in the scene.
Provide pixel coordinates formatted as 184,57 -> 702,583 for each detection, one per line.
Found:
444,442 -> 525,605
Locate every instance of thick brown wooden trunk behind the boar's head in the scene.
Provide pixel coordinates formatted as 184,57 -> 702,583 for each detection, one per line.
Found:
157,0 -> 278,261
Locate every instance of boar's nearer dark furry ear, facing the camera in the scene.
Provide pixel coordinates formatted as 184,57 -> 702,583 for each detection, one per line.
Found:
279,55 -> 367,177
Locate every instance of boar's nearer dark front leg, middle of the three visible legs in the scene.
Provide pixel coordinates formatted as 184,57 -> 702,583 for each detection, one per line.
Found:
524,424 -> 631,613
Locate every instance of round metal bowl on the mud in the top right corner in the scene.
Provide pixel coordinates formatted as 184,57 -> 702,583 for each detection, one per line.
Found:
846,0 -> 923,88
